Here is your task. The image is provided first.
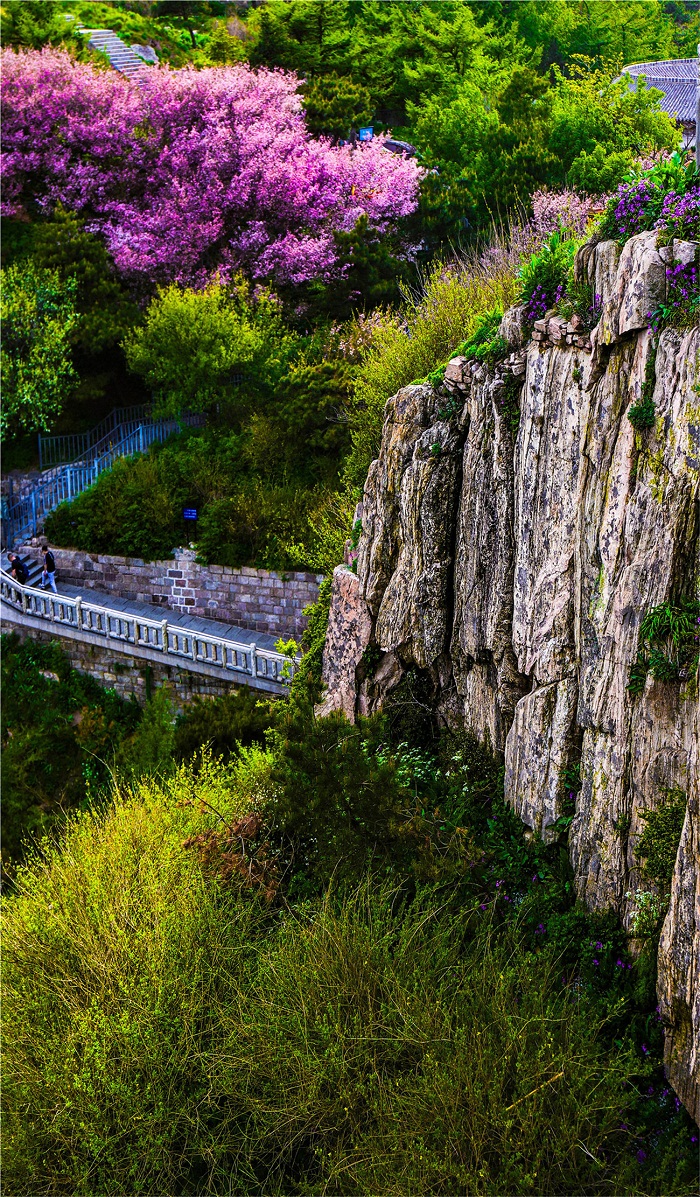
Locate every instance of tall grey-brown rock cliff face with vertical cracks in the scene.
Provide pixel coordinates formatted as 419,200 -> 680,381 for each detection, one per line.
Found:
324,233 -> 700,1118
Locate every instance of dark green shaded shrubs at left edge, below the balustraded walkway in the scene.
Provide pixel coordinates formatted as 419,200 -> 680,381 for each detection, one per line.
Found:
0,633 -> 272,876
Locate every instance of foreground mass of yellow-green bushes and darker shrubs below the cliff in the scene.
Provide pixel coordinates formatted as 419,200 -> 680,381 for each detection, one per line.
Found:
2,709 -> 695,1195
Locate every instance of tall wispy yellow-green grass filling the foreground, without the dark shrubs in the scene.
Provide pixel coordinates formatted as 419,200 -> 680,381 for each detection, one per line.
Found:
2,749 -> 665,1197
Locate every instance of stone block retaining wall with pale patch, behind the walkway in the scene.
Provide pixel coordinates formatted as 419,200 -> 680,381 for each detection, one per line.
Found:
19,537 -> 323,638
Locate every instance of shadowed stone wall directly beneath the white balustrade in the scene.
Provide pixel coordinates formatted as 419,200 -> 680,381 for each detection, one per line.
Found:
4,624 -> 242,710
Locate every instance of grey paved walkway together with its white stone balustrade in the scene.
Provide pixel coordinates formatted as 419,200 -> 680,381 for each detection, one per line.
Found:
0,572 -> 293,694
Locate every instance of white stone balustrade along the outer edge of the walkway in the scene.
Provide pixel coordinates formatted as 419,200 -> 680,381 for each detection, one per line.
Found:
0,571 -> 300,692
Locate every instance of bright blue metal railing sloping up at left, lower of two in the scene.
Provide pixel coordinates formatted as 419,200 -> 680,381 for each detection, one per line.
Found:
2,408 -> 205,548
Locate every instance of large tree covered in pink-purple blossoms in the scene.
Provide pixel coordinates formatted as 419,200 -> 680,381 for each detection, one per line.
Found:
2,49 -> 421,288
